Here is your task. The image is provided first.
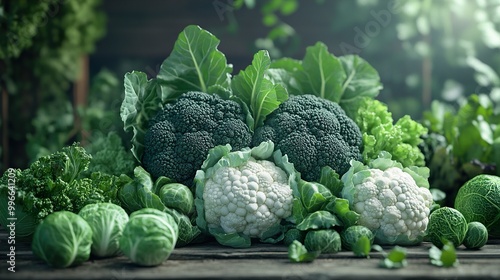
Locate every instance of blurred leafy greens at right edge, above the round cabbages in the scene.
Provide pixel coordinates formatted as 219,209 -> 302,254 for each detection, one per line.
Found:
421,94 -> 500,205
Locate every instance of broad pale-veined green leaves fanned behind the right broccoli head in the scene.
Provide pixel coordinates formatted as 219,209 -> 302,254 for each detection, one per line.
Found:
271,42 -> 382,117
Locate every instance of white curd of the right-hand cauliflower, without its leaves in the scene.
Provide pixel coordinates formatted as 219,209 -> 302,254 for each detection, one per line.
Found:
341,153 -> 433,245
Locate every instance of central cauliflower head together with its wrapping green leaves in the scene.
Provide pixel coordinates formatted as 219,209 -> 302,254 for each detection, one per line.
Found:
195,141 -> 298,248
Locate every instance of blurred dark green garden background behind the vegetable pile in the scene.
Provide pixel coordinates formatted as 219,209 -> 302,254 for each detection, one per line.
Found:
0,0 -> 500,171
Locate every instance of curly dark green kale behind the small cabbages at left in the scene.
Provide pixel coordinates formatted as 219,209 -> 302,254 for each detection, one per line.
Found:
0,143 -> 124,238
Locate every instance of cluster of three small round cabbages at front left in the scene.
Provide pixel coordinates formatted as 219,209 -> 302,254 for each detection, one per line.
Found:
32,203 -> 179,268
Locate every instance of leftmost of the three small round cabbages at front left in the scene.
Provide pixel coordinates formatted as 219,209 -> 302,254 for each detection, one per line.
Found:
31,211 -> 92,268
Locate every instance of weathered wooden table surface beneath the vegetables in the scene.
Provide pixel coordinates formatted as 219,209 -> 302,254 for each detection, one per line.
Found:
0,230 -> 500,280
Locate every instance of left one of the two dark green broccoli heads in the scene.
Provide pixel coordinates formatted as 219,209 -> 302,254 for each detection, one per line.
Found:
142,92 -> 252,186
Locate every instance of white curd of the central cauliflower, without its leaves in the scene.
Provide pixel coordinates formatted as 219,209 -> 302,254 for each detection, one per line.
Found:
203,158 -> 293,237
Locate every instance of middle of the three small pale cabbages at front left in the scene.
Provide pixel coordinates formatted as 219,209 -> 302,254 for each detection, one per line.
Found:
78,202 -> 128,258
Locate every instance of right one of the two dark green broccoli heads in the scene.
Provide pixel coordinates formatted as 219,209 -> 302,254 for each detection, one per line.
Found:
252,95 -> 362,181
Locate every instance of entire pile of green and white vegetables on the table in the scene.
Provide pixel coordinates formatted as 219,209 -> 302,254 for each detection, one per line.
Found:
0,26 -> 500,268
